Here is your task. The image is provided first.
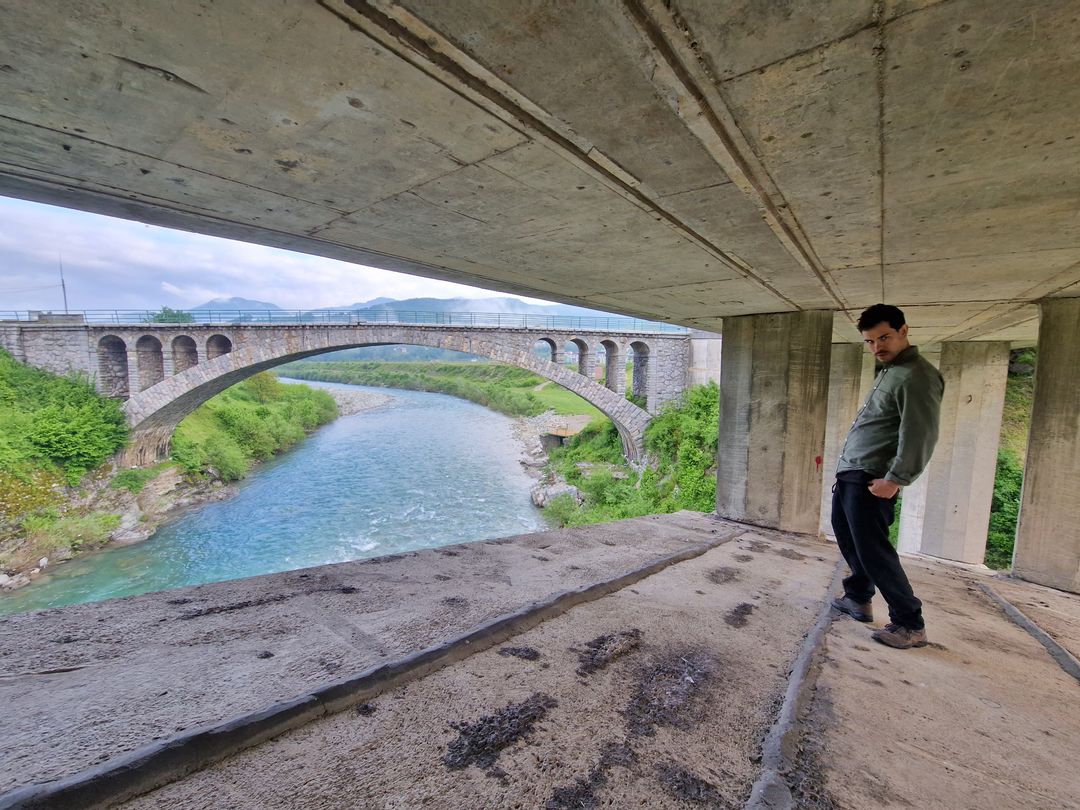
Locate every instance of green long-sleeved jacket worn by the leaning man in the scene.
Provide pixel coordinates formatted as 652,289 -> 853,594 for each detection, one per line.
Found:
836,346 -> 945,486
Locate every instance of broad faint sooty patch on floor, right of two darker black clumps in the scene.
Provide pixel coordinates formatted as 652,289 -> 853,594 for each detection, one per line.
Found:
623,650 -> 715,737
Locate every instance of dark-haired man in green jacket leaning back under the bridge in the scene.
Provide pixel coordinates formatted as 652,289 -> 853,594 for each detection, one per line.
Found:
833,303 -> 945,649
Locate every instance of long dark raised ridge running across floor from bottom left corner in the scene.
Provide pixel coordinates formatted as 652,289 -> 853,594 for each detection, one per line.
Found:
0,528 -> 745,810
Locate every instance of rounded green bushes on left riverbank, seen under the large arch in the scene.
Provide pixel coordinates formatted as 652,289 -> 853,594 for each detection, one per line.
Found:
173,373 -> 337,481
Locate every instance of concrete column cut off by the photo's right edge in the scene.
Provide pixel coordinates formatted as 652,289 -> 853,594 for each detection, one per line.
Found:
1013,298 -> 1080,593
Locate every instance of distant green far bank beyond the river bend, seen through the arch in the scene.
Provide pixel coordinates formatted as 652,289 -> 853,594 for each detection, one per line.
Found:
280,361 -> 548,416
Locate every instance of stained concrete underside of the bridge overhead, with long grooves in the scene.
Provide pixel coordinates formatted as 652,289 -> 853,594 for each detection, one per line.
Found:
0,0 -> 1080,340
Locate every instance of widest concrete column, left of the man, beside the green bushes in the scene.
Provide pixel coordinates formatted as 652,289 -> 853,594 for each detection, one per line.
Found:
716,312 -> 833,535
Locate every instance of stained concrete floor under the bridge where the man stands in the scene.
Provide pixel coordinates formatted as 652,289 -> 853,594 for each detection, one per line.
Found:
0,513 -> 1080,810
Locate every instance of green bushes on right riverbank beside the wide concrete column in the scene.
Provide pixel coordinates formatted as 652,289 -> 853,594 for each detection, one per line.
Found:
546,382 -> 719,526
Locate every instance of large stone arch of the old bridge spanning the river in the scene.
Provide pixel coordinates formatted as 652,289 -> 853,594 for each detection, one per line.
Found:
122,326 -> 651,465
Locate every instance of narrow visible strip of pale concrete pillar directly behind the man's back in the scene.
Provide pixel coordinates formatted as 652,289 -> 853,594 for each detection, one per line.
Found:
821,343 -> 874,539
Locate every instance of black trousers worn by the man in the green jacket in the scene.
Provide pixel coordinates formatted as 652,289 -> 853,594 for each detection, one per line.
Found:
833,470 -> 923,630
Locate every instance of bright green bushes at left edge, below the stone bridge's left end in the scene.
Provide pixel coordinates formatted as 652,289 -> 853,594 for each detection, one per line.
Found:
0,350 -> 127,488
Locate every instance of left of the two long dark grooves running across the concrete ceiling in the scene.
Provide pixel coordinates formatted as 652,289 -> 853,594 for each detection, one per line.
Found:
319,0 -> 802,310
